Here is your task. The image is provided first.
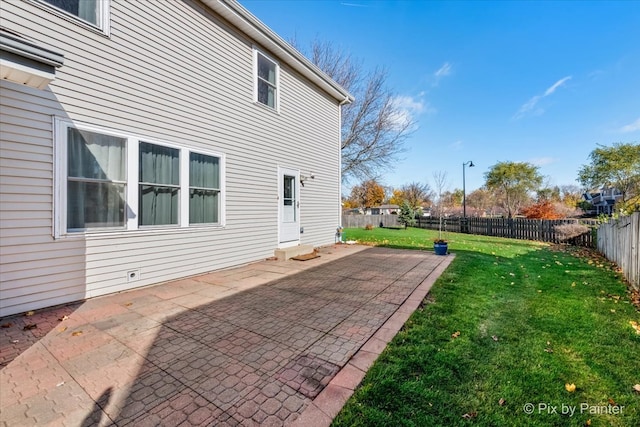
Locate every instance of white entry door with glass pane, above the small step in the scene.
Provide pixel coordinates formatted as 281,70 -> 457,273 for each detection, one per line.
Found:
278,168 -> 300,246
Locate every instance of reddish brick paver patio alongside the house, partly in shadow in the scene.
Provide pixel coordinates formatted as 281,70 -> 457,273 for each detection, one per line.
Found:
0,246 -> 452,426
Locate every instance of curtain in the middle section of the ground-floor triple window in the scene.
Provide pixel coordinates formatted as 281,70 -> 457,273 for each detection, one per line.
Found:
139,142 -> 180,225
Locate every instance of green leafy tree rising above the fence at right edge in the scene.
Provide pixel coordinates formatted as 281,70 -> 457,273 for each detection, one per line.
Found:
578,142 -> 640,203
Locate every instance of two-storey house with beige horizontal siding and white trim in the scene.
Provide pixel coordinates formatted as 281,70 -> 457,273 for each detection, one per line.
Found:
0,0 -> 353,316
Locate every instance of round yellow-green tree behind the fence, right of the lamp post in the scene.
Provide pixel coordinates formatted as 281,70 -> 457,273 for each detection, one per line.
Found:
485,162 -> 542,218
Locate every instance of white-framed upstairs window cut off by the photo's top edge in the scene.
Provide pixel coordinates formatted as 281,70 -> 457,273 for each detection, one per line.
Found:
30,0 -> 111,35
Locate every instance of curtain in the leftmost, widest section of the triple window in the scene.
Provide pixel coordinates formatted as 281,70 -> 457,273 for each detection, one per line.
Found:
67,128 -> 126,229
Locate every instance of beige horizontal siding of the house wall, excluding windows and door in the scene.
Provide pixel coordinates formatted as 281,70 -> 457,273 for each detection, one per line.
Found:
0,0 -> 340,316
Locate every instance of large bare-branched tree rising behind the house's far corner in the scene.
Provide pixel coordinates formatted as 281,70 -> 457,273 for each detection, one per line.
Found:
292,40 -> 415,181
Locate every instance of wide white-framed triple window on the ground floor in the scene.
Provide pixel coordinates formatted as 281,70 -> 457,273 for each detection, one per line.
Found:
54,118 -> 225,237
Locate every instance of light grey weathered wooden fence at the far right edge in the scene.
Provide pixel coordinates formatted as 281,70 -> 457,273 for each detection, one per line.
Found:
598,212 -> 640,290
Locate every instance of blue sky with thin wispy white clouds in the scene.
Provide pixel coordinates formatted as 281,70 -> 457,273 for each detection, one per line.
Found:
240,0 -> 640,192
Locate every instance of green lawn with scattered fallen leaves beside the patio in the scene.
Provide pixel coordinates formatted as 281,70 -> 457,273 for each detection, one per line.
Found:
333,228 -> 640,426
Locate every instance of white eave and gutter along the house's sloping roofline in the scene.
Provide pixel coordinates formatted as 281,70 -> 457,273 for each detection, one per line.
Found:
201,0 -> 355,103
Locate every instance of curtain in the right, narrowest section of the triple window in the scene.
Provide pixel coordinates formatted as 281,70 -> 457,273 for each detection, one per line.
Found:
189,153 -> 220,224
